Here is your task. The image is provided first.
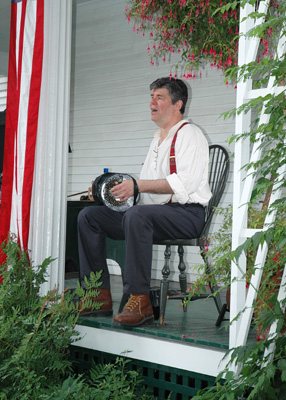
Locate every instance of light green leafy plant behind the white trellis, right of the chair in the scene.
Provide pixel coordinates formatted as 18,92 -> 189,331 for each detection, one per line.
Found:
189,202 -> 286,324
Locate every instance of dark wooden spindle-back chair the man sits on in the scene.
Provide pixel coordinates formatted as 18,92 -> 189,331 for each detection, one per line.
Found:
154,145 -> 229,326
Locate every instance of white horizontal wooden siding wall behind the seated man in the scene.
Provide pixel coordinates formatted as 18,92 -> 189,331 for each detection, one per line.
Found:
68,0 -> 235,280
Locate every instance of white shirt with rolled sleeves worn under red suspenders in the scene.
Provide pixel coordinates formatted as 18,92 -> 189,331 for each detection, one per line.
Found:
140,120 -> 211,206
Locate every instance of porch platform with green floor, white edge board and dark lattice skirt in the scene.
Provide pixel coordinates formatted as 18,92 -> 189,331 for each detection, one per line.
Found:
65,274 -> 255,399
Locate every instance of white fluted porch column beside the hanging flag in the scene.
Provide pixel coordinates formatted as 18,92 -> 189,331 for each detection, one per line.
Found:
29,0 -> 72,294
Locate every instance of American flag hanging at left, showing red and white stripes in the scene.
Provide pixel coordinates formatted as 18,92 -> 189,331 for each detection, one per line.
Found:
0,0 -> 44,262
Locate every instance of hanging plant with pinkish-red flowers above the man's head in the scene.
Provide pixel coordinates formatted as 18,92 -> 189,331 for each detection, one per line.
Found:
126,0 -> 239,77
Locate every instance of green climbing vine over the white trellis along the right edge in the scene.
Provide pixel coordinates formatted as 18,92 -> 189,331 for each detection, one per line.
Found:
187,0 -> 286,400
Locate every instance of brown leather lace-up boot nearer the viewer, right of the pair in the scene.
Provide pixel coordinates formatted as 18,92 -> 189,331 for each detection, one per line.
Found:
114,294 -> 154,326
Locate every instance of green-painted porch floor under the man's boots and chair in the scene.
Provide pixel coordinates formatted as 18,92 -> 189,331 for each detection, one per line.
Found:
65,275 -> 256,349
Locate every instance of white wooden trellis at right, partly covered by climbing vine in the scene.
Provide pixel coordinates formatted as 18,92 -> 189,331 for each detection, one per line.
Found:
229,1 -> 286,358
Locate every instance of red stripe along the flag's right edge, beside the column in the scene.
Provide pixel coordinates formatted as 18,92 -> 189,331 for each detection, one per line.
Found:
22,0 -> 44,249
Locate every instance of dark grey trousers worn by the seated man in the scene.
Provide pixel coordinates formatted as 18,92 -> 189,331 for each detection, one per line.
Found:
78,203 -> 205,294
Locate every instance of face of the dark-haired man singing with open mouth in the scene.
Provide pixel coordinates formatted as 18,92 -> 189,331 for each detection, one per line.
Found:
150,88 -> 180,127
